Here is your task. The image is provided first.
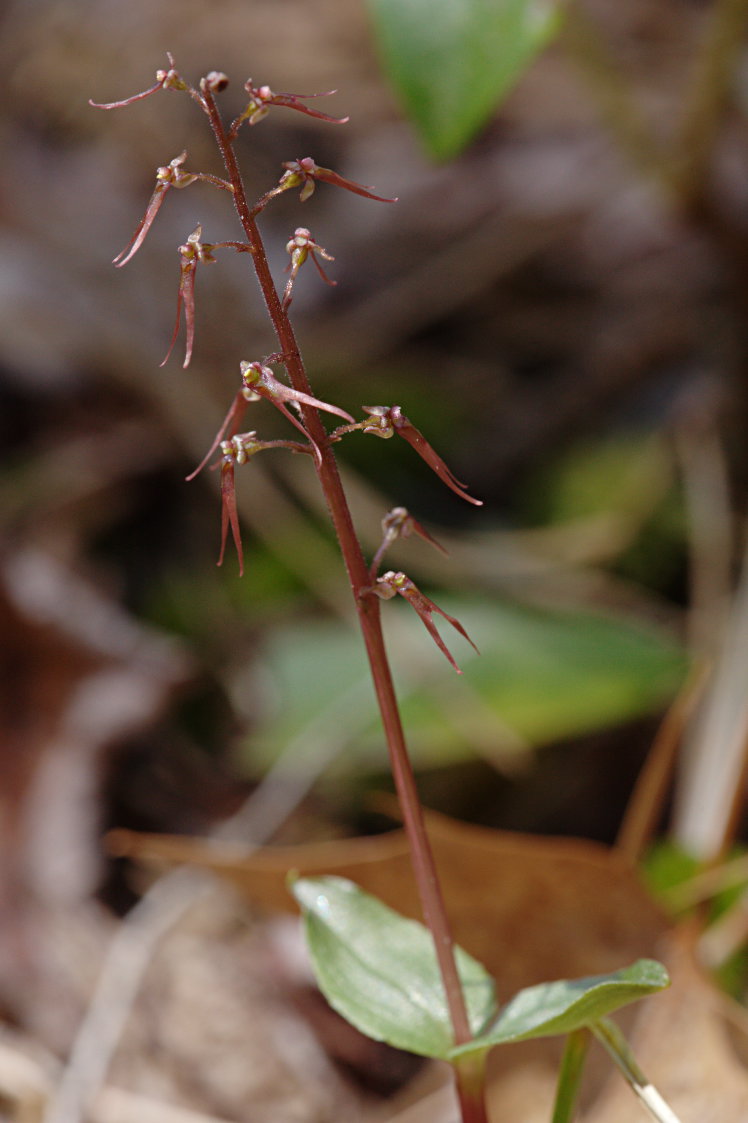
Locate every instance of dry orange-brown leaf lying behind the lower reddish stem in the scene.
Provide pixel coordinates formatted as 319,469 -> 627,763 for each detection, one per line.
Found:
110,813 -> 667,994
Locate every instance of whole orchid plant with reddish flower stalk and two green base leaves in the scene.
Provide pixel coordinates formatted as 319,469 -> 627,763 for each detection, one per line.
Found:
92,55 -> 674,1123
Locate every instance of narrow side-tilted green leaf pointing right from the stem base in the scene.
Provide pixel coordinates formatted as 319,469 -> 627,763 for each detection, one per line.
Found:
448,959 -> 671,1059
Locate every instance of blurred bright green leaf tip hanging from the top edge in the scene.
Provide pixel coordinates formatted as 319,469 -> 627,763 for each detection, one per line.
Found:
368,0 -> 559,159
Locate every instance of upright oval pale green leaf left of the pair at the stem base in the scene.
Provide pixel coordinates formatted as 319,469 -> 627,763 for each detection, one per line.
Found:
291,877 -> 496,1058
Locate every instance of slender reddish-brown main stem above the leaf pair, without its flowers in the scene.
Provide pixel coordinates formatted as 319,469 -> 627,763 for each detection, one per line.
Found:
196,82 -> 467,1051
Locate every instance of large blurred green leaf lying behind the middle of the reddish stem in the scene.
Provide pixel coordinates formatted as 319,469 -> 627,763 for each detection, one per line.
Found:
243,590 -> 686,780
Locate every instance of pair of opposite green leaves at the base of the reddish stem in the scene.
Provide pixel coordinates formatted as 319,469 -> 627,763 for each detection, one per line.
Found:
292,877 -> 669,1060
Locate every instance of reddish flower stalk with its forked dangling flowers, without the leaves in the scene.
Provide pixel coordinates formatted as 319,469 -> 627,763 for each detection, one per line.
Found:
92,55 -> 473,1069
